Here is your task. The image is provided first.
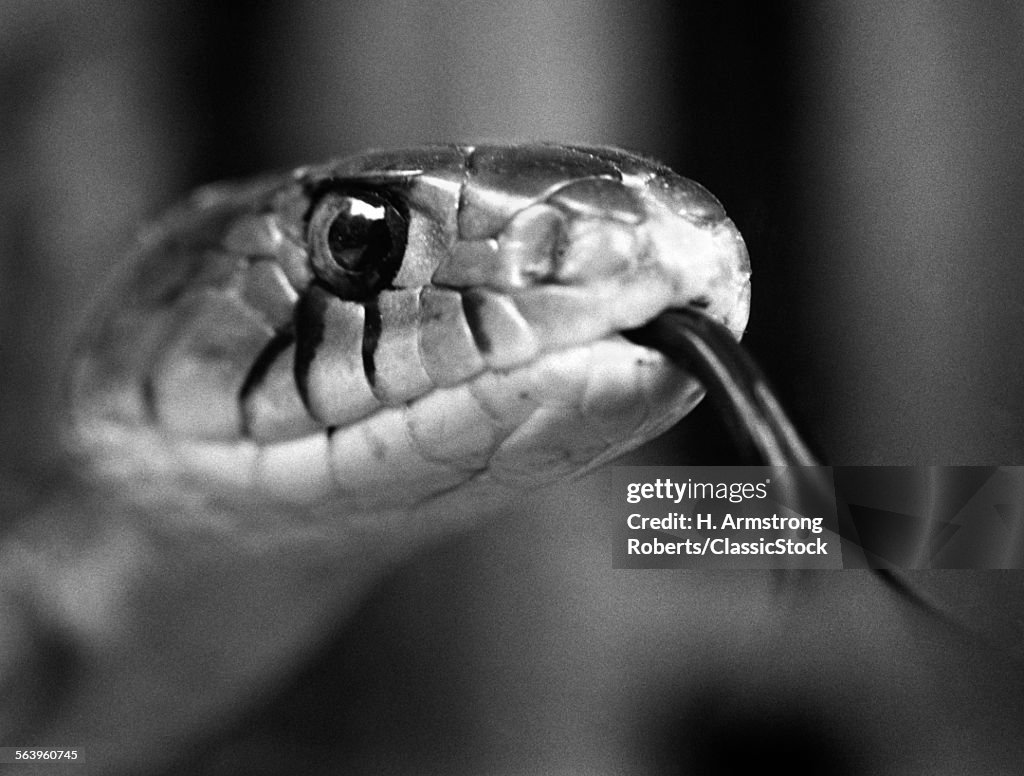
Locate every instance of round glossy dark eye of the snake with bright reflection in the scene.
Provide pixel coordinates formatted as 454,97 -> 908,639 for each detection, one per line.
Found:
308,190 -> 409,300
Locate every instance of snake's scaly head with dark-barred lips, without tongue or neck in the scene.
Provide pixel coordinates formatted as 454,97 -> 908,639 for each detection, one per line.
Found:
71,144 -> 750,524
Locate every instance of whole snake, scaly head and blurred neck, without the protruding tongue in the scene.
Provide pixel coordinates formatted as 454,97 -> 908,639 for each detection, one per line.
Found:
0,143 -> 751,773
